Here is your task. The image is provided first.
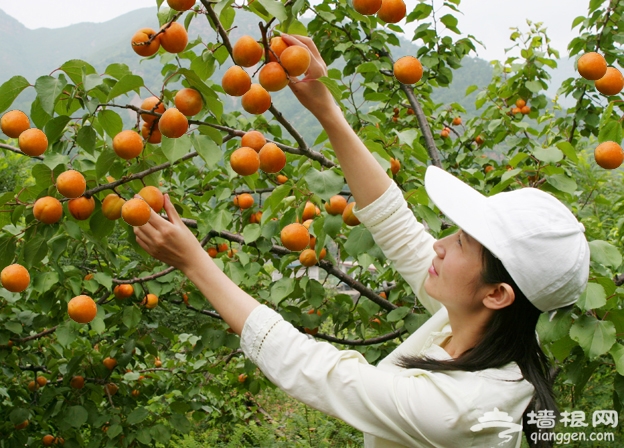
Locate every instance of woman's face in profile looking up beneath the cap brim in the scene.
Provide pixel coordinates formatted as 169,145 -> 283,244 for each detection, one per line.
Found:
425,230 -> 487,311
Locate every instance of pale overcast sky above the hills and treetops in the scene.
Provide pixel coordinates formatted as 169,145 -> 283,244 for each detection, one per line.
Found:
0,0 -> 589,60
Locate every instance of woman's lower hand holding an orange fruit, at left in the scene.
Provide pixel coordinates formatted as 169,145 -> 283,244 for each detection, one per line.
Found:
134,194 -> 204,272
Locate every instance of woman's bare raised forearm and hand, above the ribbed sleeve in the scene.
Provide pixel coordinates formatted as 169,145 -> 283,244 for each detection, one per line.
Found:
282,35 -> 392,208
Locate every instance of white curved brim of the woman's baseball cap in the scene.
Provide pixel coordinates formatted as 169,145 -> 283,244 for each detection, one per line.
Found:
425,166 -> 497,255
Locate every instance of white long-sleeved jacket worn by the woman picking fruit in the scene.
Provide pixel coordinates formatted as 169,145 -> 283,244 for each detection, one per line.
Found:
241,183 -> 534,448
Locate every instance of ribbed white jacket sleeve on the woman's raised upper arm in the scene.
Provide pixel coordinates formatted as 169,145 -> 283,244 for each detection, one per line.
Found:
355,182 -> 442,314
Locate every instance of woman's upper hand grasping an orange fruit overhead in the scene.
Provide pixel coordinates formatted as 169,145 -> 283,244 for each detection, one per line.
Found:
281,34 -> 337,118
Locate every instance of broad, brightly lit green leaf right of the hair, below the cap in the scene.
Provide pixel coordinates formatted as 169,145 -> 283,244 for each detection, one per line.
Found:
570,314 -> 615,360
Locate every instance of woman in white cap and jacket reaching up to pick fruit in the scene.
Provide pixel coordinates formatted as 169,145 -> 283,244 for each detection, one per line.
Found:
134,36 -> 589,447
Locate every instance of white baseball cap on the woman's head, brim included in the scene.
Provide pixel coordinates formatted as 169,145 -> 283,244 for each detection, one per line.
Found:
425,166 -> 589,311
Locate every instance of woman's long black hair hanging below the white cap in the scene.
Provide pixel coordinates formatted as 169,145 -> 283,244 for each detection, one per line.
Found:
399,247 -> 557,447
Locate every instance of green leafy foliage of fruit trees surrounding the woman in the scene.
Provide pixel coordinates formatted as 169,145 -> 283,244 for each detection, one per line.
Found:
0,0 -> 624,448
